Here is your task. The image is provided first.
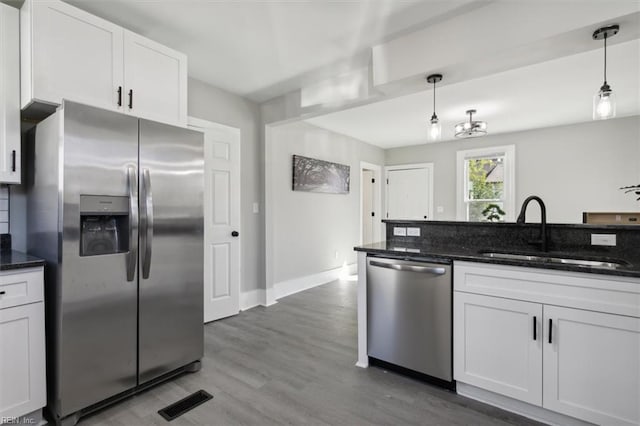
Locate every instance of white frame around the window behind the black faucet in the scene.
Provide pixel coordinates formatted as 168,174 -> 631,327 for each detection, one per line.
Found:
456,145 -> 516,222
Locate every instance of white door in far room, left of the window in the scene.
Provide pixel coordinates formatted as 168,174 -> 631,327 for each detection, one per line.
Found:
387,165 -> 433,220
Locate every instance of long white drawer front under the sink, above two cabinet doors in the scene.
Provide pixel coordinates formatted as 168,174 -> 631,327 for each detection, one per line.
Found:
453,262 -> 640,317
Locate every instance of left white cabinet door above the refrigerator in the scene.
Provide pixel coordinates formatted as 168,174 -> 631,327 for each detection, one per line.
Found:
20,0 -> 124,110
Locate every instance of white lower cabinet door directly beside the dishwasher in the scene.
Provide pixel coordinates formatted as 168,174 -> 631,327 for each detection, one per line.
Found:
454,292 -> 542,405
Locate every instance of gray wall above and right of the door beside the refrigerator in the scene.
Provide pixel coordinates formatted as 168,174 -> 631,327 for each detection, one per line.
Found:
188,78 -> 265,291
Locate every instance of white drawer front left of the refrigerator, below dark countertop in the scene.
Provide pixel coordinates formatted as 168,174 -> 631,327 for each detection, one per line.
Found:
0,268 -> 44,309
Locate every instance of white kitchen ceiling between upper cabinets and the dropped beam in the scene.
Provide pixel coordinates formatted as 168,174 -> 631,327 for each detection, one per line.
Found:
68,0 -> 476,102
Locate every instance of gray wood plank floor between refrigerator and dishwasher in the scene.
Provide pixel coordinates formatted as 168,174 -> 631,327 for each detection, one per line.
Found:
80,281 -> 537,426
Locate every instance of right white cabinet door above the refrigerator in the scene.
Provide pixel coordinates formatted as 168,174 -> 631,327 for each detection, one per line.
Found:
124,31 -> 187,126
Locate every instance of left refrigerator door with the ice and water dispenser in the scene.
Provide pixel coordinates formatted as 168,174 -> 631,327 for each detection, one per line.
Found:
57,101 -> 138,416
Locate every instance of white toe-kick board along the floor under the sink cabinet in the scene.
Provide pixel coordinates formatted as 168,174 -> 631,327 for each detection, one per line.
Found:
456,382 -> 591,426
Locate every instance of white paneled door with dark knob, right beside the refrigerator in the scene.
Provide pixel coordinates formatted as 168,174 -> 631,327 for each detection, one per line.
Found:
189,118 -> 241,322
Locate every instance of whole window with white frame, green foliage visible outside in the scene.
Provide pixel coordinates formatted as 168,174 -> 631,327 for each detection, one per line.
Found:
457,145 -> 515,222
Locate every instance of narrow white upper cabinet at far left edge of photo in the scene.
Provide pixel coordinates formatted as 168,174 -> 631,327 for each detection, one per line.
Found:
0,3 -> 20,183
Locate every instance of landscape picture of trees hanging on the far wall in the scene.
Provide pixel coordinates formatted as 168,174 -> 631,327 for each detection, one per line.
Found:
293,155 -> 351,194
